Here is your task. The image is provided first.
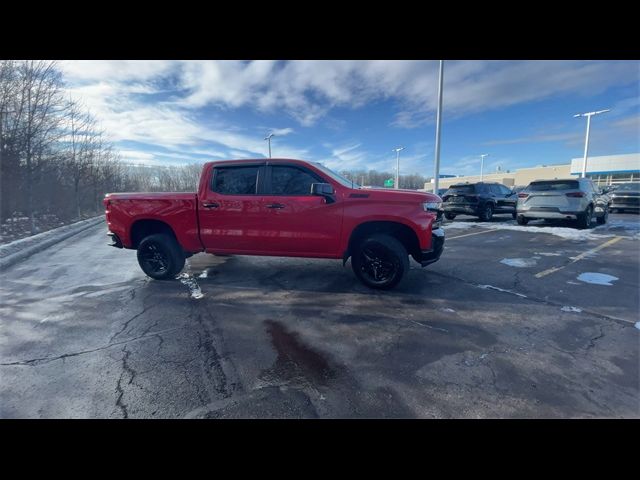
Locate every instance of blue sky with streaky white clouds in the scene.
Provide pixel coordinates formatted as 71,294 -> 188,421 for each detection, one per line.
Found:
59,60 -> 640,176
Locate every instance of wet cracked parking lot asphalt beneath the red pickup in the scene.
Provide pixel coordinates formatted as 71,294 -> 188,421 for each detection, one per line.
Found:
0,214 -> 640,418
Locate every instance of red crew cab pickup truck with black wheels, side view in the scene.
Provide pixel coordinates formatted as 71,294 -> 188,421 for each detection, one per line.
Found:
104,159 -> 444,289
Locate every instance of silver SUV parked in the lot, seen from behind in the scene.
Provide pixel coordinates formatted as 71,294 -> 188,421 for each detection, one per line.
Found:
516,178 -> 610,228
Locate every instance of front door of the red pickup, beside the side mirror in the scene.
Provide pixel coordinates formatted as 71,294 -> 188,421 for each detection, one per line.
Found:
262,164 -> 342,257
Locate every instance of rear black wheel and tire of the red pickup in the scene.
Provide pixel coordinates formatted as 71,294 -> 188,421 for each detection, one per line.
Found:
138,233 -> 185,280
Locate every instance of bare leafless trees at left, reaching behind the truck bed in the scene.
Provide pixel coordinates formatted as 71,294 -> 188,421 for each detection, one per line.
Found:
0,60 -> 202,233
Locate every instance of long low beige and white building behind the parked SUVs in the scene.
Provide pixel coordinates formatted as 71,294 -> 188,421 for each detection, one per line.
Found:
424,153 -> 640,191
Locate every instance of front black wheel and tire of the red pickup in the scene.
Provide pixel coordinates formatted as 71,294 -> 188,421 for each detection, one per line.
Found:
351,233 -> 409,290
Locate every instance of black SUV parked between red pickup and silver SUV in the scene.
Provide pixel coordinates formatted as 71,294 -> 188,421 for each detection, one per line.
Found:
442,182 -> 518,222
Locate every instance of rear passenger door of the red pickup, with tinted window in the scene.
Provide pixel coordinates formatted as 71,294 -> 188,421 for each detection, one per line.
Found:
198,162 -> 265,253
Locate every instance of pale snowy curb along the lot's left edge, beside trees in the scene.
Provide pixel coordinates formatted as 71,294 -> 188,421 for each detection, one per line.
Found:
0,215 -> 105,270
